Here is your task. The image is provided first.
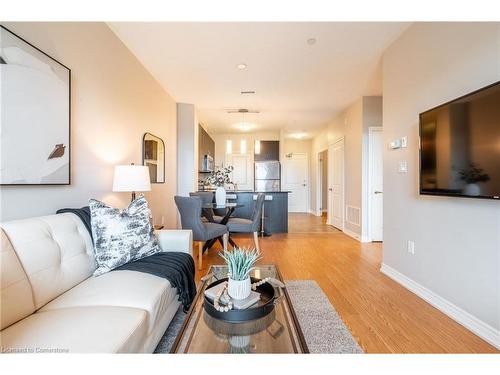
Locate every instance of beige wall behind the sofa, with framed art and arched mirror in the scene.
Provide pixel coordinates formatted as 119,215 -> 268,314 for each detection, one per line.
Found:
0,23 -> 176,227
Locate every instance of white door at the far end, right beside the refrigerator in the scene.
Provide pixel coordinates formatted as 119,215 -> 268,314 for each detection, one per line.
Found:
284,154 -> 309,212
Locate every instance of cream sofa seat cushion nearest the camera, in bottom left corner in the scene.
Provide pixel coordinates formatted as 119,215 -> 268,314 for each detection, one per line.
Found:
0,306 -> 147,353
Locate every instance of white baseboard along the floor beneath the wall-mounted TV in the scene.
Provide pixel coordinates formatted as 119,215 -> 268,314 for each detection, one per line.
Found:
380,263 -> 500,349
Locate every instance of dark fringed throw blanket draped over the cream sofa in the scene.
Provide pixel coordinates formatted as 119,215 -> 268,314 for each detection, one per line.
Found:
56,206 -> 196,312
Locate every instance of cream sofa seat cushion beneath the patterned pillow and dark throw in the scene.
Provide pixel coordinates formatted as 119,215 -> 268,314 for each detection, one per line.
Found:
40,271 -> 178,332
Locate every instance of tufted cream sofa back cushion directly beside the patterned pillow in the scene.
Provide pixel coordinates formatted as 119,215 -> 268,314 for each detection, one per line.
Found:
1,213 -> 95,309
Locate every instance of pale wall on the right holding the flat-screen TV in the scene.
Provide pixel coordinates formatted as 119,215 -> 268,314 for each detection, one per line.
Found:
383,23 -> 500,345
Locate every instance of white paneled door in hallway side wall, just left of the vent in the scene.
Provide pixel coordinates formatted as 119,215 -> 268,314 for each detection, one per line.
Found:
328,139 -> 344,230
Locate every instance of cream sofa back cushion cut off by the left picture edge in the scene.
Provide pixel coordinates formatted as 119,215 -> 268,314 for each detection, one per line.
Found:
0,229 -> 35,330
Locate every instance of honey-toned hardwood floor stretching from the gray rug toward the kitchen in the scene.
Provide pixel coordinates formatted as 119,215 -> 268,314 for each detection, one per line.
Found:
197,214 -> 499,353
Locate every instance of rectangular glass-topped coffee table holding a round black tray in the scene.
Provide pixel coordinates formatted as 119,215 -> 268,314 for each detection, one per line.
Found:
170,265 -> 309,354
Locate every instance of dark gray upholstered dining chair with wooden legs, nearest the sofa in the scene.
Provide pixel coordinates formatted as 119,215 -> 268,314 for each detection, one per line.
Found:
174,195 -> 229,270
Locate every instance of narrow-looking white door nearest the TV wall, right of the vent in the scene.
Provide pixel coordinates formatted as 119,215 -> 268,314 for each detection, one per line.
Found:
368,127 -> 384,241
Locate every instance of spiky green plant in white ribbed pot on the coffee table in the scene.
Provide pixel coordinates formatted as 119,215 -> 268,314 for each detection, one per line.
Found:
219,247 -> 260,299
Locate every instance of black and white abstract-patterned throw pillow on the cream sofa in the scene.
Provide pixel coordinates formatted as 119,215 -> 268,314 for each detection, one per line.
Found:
89,196 -> 160,276
